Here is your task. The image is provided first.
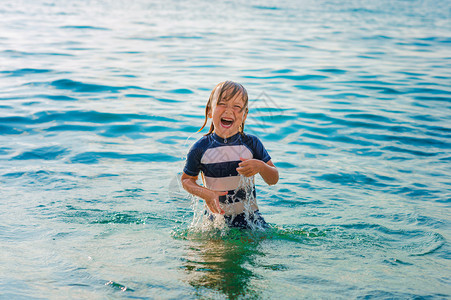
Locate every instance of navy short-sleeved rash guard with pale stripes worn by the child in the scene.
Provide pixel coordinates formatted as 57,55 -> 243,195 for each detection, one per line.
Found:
183,133 -> 271,203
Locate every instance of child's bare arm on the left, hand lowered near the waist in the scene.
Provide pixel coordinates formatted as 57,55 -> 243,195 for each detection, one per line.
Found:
181,173 -> 227,215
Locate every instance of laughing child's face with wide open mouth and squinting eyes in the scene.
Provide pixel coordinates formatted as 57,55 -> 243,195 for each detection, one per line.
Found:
209,94 -> 247,139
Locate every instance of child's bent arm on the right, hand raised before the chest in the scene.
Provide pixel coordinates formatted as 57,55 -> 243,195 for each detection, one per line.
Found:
236,158 -> 279,185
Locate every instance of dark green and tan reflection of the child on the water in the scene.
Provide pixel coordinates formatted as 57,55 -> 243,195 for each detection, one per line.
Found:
184,230 -> 264,299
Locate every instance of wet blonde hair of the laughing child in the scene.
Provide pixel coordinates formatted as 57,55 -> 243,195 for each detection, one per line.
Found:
197,81 -> 249,135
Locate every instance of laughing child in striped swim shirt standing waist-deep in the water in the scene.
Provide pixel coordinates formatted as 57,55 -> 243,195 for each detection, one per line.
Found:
181,81 -> 279,228
